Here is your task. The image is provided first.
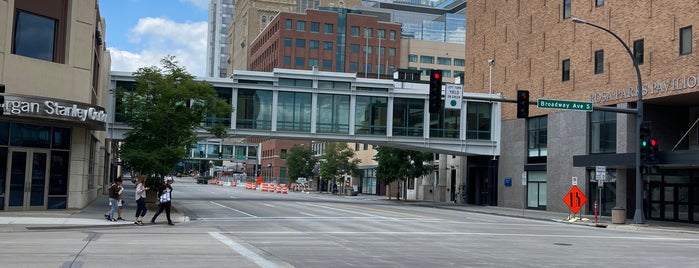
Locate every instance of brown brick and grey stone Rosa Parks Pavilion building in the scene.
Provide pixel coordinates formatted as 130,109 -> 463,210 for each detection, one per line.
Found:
465,0 -> 699,223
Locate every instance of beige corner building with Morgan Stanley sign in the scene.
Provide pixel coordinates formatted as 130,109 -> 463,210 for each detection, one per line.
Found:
0,0 -> 115,211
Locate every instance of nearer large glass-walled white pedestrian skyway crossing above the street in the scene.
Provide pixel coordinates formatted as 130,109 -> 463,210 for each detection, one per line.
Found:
107,69 -> 501,157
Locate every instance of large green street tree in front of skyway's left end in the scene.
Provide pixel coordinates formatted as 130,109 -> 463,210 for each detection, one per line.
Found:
117,56 -> 232,182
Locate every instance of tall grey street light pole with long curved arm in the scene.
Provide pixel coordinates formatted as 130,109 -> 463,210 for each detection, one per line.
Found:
572,18 -> 646,224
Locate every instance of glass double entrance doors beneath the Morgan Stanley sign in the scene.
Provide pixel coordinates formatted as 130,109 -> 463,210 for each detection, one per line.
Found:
7,149 -> 49,210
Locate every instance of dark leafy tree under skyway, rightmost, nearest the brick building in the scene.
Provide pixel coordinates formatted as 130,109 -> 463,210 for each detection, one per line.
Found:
374,146 -> 434,199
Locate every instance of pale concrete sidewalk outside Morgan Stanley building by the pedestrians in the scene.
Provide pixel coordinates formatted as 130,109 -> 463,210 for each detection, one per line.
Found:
0,177 -> 189,229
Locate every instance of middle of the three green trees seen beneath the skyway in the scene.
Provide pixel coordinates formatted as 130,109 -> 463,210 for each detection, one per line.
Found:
320,142 -> 361,191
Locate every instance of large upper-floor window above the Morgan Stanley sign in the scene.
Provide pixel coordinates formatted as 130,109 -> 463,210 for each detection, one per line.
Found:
12,10 -> 58,61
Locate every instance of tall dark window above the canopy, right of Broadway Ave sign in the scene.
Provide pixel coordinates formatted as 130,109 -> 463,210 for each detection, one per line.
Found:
590,111 -> 616,154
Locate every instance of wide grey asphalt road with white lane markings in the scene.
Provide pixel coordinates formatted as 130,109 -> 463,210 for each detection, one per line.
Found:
0,177 -> 699,267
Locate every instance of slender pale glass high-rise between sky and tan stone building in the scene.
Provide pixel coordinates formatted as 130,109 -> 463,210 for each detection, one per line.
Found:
206,0 -> 235,77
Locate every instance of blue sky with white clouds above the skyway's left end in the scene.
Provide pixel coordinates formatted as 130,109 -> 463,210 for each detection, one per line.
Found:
99,0 -> 211,76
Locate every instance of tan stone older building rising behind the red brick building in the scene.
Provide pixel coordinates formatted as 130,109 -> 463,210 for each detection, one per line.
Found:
228,0 -> 361,75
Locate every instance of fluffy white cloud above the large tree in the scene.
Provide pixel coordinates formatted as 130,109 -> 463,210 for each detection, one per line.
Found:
109,17 -> 208,76
